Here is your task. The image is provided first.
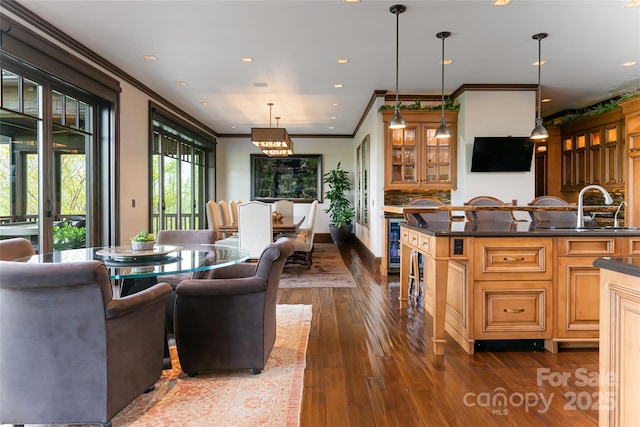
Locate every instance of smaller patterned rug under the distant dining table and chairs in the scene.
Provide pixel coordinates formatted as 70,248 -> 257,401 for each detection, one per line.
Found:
280,243 -> 356,288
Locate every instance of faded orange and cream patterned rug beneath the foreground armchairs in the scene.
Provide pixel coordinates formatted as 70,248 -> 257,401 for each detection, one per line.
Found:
113,304 -> 311,427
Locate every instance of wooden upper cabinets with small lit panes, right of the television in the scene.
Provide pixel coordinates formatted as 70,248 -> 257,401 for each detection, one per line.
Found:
561,109 -> 625,191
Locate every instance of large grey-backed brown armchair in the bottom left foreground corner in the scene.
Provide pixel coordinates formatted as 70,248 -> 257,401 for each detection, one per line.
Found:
0,261 -> 171,426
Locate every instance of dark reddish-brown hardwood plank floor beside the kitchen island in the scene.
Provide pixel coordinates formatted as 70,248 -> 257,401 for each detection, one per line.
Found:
278,245 -> 598,427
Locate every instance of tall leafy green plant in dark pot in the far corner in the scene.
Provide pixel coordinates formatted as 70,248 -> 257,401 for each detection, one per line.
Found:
324,162 -> 355,243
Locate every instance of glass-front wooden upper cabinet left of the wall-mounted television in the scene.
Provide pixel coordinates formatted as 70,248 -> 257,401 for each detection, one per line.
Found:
382,110 -> 458,189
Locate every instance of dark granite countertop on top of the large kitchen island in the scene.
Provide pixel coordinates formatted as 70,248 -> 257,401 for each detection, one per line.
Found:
401,221 -> 640,237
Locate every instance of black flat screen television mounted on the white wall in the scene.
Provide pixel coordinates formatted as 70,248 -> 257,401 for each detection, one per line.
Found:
471,136 -> 534,172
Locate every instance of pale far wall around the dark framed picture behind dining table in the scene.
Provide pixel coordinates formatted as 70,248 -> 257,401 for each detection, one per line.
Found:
216,138 -> 355,237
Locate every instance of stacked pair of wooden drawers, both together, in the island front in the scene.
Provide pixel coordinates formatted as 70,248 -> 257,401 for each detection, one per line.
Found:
473,238 -> 553,339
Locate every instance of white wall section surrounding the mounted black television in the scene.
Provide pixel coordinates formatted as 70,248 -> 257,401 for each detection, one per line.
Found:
451,91 -> 536,219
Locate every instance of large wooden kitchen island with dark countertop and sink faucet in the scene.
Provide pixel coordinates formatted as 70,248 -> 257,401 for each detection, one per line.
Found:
400,221 -> 640,354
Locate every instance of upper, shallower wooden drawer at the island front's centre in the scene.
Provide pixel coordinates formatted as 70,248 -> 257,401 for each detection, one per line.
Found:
474,239 -> 553,280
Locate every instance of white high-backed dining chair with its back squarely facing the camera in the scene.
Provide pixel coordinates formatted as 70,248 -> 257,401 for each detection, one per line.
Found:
238,200 -> 273,259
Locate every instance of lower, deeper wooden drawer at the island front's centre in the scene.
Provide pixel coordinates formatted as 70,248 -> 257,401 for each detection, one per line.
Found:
475,281 -> 553,339
